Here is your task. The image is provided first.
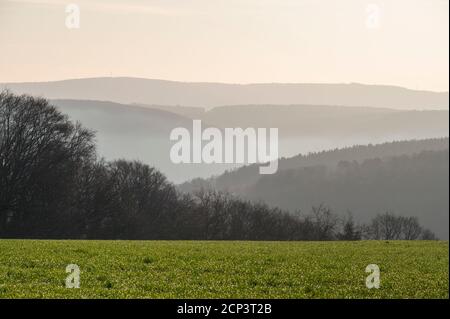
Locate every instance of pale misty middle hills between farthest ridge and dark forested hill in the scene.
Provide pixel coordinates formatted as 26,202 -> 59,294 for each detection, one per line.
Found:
52,100 -> 448,183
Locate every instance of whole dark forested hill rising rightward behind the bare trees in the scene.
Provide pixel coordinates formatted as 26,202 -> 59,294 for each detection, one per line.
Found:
179,138 -> 449,239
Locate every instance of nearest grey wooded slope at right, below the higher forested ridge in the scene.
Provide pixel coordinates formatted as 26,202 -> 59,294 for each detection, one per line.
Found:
248,149 -> 449,239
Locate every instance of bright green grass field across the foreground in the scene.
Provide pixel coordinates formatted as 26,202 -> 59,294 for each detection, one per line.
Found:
0,240 -> 449,298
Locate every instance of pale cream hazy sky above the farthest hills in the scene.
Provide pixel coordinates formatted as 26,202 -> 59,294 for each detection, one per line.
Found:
0,0 -> 449,91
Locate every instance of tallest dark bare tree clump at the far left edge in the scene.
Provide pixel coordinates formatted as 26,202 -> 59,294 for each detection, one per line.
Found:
0,91 -> 95,236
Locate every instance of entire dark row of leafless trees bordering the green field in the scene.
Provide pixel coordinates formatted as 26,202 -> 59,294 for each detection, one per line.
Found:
0,91 -> 434,240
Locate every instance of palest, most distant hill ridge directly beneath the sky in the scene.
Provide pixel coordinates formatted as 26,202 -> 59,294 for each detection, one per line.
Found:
0,77 -> 449,110
